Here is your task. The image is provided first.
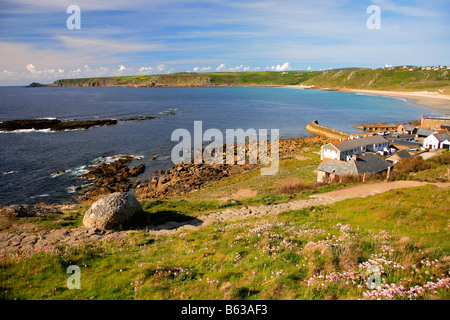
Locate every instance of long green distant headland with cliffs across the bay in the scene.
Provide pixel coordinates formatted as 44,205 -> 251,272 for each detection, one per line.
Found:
30,66 -> 450,94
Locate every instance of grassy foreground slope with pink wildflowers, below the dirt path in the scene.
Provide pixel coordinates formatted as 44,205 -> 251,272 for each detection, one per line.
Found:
0,186 -> 450,299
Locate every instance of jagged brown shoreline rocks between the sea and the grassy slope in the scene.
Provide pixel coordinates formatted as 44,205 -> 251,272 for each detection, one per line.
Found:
71,136 -> 330,202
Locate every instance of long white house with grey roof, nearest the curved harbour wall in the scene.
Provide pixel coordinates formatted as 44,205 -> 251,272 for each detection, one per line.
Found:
320,136 -> 389,161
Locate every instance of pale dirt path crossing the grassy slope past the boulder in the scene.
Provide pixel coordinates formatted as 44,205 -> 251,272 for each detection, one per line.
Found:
0,181 -> 450,254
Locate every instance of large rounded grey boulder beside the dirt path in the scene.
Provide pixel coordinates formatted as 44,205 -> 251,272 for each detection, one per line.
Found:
83,192 -> 142,230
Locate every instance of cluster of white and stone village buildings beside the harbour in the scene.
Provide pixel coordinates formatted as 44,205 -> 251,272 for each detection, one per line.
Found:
314,115 -> 450,182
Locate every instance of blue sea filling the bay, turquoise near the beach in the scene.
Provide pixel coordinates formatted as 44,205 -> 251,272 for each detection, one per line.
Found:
0,87 -> 440,205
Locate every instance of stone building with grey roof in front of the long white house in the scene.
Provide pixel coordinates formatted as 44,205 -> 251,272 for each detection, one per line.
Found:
316,153 -> 393,182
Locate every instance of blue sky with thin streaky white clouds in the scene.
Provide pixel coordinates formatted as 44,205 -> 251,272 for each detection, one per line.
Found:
0,0 -> 450,86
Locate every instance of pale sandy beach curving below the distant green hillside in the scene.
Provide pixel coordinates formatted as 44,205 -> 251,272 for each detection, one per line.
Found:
282,86 -> 450,115
